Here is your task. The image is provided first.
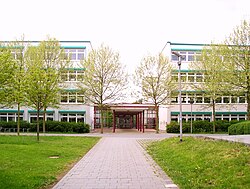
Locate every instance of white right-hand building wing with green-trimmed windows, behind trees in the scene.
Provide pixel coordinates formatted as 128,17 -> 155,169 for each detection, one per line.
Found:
163,42 -> 247,129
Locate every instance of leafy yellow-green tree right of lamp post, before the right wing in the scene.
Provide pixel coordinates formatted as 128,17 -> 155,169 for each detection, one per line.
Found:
191,44 -> 230,132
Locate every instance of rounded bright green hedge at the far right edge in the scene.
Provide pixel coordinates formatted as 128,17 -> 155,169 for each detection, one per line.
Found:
228,121 -> 250,135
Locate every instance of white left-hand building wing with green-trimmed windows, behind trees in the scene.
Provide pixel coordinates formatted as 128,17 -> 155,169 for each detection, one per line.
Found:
0,41 -> 93,125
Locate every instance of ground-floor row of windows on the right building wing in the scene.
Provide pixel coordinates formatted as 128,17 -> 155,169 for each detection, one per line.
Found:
171,114 -> 247,122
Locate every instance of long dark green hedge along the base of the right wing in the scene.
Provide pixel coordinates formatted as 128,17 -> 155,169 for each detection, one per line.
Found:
166,120 -> 239,133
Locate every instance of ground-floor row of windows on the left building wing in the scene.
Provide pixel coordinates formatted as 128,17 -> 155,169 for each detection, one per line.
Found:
0,113 -> 85,123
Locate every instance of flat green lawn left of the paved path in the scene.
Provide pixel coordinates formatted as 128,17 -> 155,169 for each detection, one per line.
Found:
0,136 -> 99,189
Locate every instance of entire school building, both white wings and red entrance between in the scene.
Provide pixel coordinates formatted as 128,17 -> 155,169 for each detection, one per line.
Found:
0,41 -> 247,131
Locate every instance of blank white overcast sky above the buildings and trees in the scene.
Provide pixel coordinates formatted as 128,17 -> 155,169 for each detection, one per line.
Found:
0,0 -> 250,71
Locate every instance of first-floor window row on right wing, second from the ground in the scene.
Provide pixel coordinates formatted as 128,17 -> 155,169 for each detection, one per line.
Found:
171,93 -> 247,104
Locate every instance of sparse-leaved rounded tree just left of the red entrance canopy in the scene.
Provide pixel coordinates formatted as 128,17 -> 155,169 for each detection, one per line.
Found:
78,45 -> 127,133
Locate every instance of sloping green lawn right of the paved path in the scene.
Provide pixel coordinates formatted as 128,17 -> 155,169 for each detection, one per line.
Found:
148,137 -> 250,189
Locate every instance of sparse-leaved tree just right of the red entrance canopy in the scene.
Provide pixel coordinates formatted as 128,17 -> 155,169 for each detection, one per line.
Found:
135,55 -> 177,133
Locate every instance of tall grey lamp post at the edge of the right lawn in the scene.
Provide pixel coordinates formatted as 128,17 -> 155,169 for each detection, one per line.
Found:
172,52 -> 182,142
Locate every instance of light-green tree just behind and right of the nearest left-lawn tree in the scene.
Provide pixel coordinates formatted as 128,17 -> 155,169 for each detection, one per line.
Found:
38,37 -> 69,132
